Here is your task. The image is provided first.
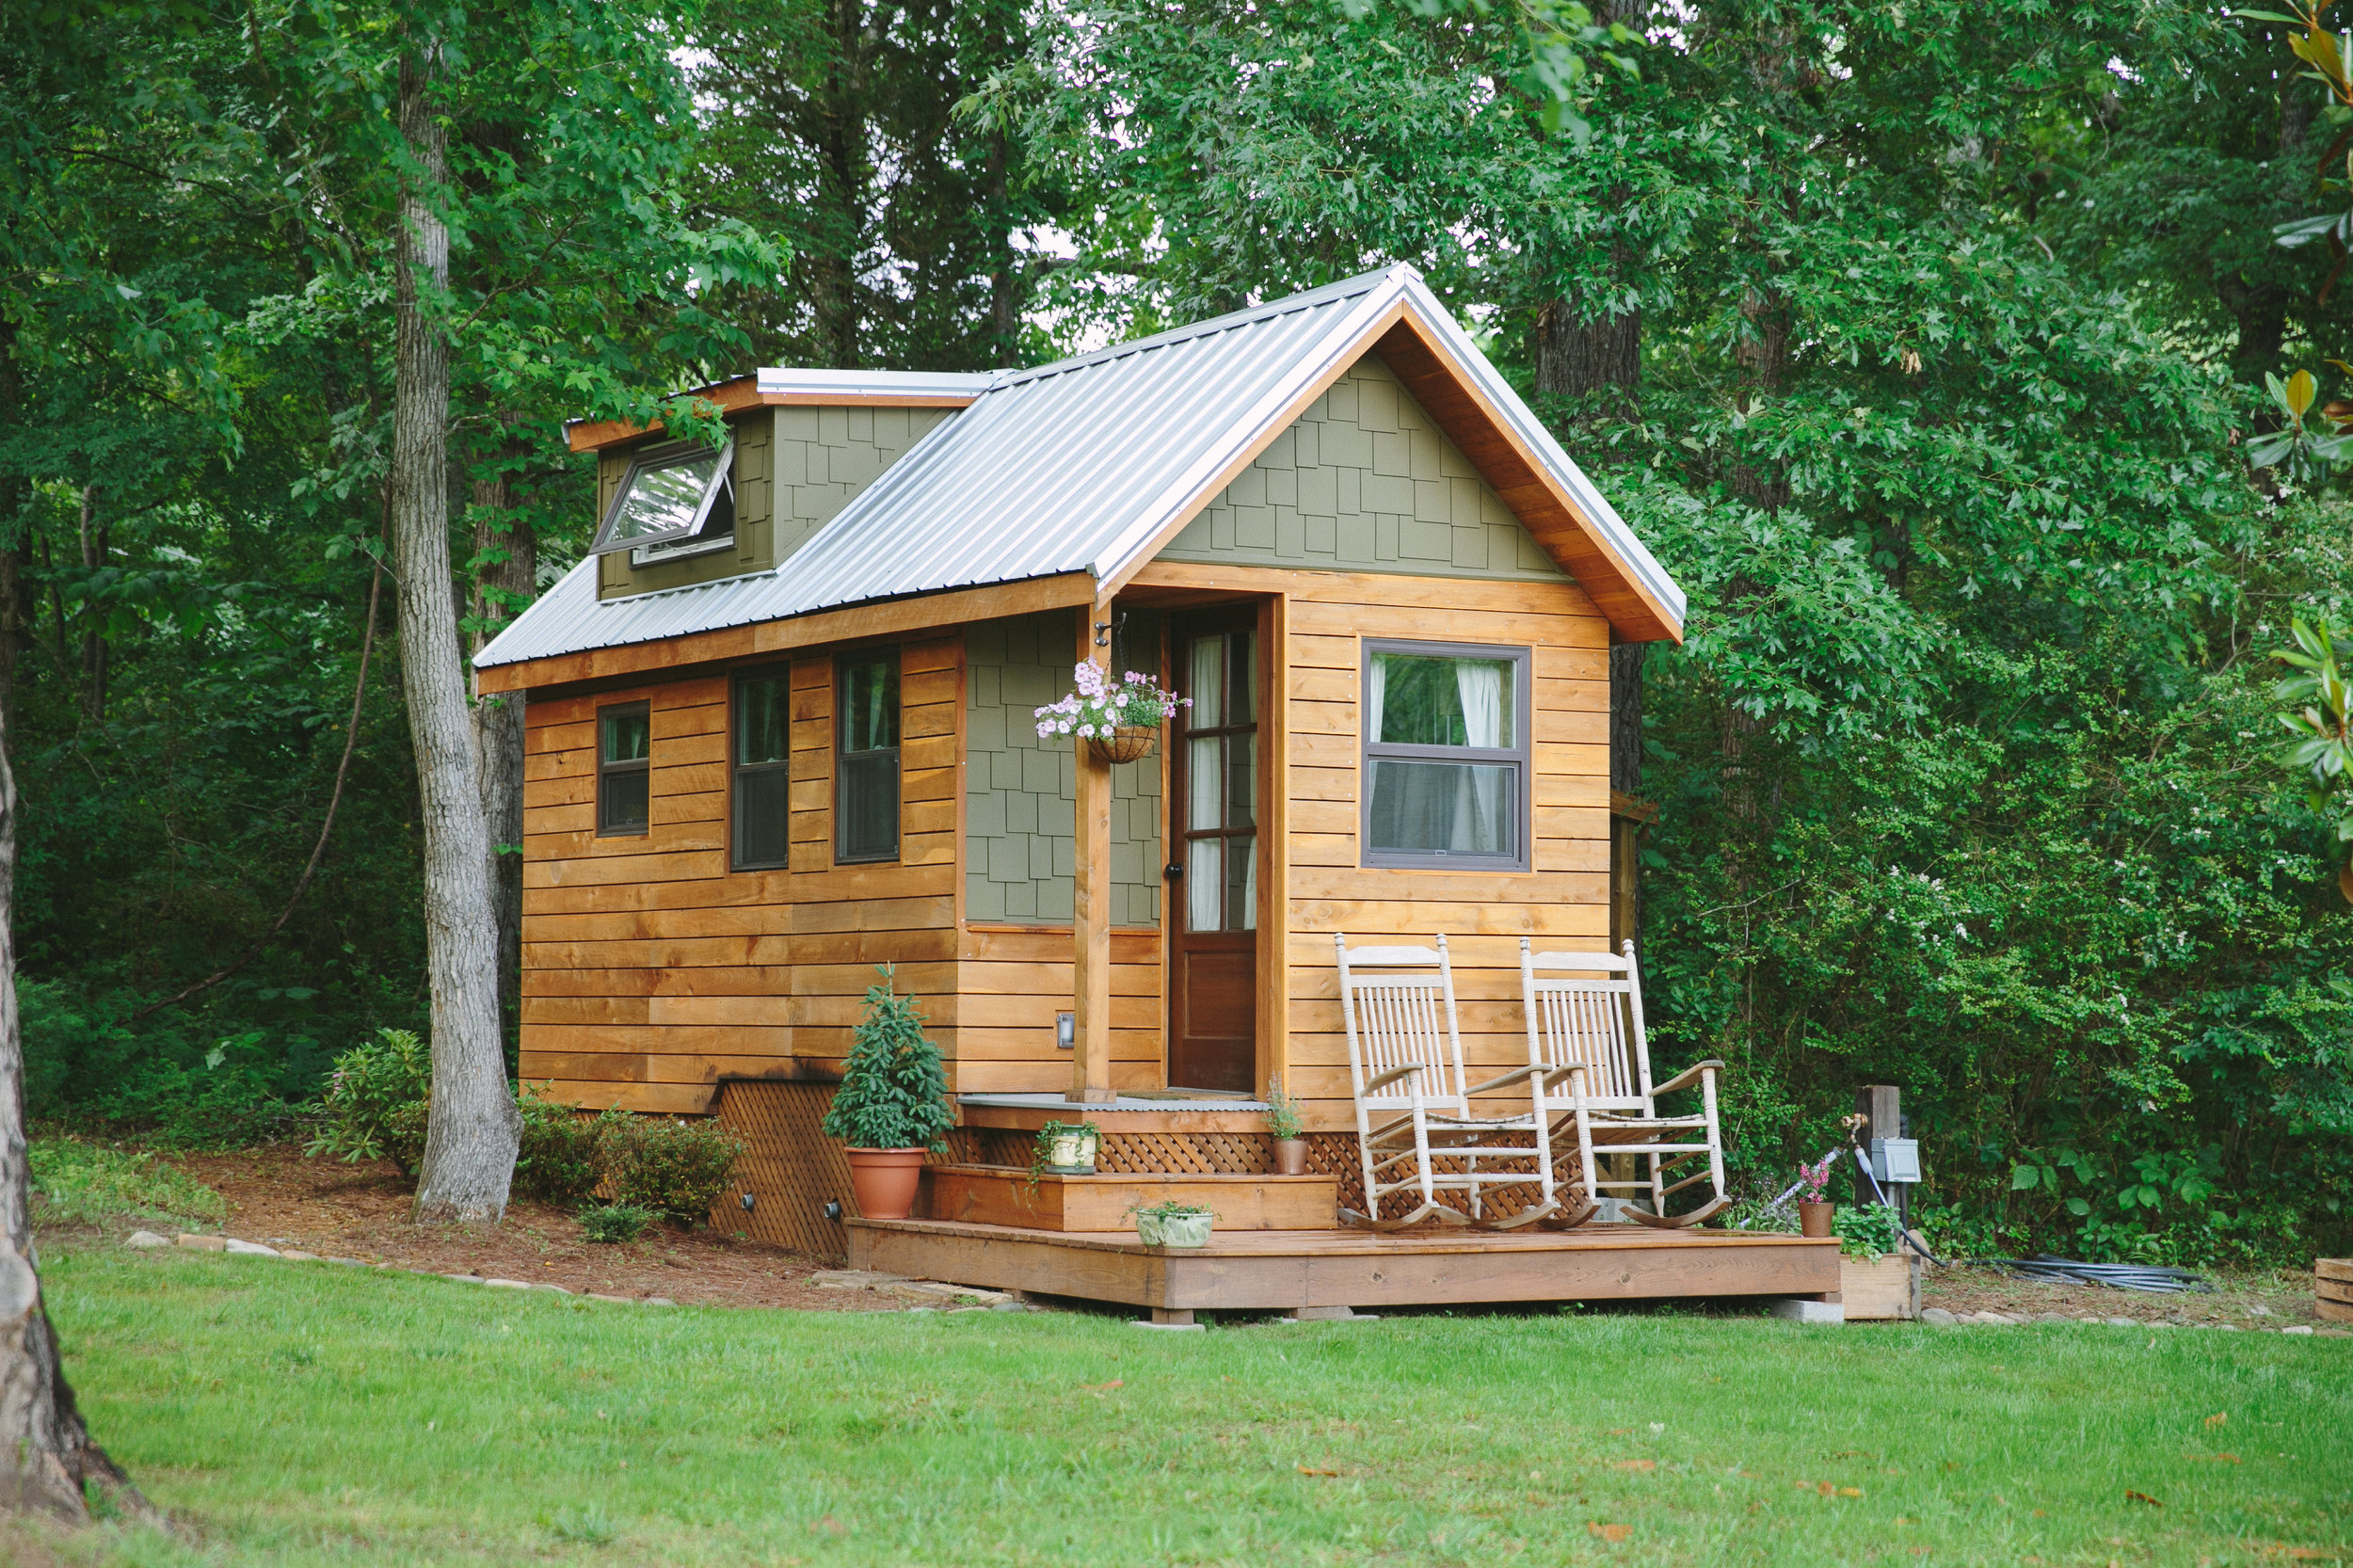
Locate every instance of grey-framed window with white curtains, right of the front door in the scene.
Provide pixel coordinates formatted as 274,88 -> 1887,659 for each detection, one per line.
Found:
1363,643 -> 1529,872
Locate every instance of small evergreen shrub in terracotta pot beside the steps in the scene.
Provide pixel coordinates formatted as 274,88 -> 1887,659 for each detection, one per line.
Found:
824,963 -> 955,1220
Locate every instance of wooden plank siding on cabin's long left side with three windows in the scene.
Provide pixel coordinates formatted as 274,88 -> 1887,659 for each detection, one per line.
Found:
520,635 -> 963,1112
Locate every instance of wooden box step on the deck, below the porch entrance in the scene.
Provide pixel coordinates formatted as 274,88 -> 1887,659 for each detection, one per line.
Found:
927,1165 -> 1339,1231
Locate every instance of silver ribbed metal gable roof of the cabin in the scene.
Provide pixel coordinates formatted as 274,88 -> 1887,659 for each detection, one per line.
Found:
475,266 -> 1685,668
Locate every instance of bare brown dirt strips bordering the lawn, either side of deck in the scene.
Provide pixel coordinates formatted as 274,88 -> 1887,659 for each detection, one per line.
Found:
45,1144 -> 2320,1330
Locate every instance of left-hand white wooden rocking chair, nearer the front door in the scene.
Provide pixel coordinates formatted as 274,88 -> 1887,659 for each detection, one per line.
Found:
1332,937 -> 1561,1231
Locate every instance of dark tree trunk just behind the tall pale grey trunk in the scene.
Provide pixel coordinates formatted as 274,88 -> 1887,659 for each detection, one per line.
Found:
471,463 -> 539,1049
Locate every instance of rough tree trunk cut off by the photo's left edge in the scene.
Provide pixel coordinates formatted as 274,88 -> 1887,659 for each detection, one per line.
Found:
0,440 -> 155,1521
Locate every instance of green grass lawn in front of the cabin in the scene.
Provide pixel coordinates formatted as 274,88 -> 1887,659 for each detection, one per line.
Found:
18,1250 -> 2353,1568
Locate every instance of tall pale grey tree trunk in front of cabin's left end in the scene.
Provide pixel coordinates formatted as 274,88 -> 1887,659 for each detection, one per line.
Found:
391,38 -> 520,1224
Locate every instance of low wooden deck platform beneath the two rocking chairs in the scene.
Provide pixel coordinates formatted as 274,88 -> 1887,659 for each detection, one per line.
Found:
847,1220 -> 1838,1320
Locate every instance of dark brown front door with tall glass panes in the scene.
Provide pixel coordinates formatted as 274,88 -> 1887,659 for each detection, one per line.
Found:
1170,612 -> 1259,1095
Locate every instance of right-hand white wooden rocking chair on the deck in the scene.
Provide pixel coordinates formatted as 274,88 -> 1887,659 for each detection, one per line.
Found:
1520,937 -> 1732,1229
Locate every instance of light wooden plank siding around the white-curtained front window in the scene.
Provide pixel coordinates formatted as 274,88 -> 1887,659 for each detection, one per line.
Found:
1137,563 -> 1609,1132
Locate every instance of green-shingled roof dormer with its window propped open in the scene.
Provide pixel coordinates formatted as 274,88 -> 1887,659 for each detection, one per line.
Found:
585,370 -> 988,600
